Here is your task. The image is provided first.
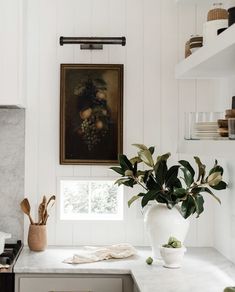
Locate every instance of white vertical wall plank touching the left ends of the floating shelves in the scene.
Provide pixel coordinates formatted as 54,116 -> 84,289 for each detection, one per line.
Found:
161,0 -> 178,153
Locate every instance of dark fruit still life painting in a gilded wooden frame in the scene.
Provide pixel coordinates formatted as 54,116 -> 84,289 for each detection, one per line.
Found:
60,64 -> 123,165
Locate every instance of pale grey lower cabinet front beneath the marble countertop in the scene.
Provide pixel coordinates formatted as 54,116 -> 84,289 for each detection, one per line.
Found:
15,274 -> 133,292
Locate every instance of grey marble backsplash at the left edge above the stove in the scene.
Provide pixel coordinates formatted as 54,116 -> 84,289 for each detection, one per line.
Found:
0,109 -> 25,240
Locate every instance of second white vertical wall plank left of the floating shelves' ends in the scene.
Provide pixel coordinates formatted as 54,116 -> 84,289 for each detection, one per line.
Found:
143,0 -> 162,151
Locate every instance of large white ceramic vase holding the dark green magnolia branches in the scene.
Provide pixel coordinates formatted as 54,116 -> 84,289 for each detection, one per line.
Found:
144,203 -> 189,259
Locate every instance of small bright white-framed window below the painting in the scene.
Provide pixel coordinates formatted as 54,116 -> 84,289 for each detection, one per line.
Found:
59,179 -> 123,220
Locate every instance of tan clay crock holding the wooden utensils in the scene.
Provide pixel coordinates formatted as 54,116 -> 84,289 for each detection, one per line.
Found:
28,224 -> 47,251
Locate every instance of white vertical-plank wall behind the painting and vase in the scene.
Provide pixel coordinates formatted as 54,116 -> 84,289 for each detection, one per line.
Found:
25,0 -> 214,246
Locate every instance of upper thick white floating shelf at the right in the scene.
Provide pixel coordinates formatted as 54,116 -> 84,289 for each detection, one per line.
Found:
175,24 -> 235,79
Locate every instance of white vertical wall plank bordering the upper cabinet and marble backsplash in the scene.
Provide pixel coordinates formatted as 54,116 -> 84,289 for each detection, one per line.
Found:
24,0 -> 40,242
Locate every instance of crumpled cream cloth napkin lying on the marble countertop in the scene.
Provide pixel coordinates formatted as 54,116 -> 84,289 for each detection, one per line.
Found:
63,243 -> 137,264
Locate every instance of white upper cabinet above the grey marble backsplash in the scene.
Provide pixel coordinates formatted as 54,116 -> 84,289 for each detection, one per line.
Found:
0,0 -> 25,107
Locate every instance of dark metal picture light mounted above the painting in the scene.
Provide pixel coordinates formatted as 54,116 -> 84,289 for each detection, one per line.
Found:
60,36 -> 126,50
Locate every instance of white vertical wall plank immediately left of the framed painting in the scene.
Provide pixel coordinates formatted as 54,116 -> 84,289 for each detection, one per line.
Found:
38,0 -> 59,244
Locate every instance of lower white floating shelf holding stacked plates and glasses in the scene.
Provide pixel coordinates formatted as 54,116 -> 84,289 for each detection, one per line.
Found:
178,139 -> 235,158
